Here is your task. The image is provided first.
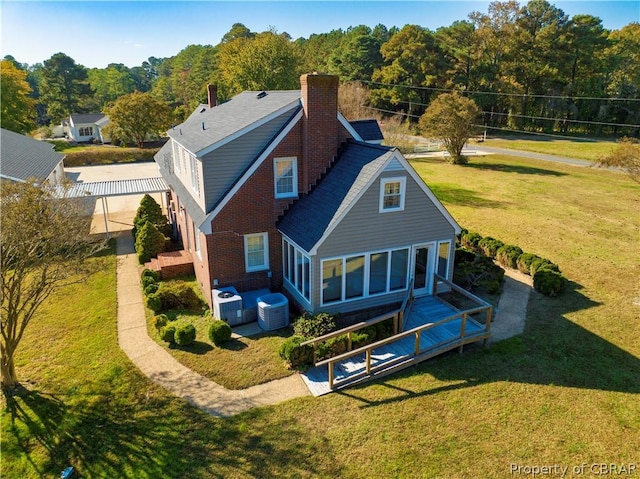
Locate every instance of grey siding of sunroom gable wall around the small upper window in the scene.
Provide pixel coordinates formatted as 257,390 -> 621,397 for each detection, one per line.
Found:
311,171 -> 455,312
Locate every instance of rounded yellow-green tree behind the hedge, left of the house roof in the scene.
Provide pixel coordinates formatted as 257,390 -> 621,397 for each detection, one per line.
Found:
106,92 -> 172,148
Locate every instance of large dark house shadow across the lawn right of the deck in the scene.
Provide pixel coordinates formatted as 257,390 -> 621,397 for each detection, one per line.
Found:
339,283 -> 640,407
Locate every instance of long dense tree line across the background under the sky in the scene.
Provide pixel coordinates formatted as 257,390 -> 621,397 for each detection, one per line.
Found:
2,0 -> 640,136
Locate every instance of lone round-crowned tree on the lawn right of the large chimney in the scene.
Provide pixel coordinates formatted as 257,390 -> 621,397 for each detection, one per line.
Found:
419,92 -> 480,164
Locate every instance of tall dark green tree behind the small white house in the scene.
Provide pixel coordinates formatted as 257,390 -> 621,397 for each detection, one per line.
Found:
40,53 -> 91,122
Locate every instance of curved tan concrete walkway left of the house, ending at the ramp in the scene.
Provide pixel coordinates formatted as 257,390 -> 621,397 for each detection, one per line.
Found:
116,233 -> 311,417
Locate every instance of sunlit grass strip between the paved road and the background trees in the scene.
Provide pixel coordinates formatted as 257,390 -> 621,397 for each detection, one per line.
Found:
478,137 -> 616,161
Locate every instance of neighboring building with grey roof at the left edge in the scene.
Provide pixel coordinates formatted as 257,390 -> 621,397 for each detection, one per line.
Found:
0,129 -> 65,185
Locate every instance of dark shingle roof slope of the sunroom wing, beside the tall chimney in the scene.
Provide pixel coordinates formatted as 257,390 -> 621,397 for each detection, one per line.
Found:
278,142 -> 394,251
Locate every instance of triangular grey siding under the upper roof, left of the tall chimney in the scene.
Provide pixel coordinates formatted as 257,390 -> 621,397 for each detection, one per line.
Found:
201,106 -> 297,211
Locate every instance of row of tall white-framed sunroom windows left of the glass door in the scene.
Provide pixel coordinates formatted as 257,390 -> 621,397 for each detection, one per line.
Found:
322,248 -> 409,305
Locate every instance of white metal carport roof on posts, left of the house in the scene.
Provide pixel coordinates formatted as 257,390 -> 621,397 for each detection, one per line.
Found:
54,176 -> 169,238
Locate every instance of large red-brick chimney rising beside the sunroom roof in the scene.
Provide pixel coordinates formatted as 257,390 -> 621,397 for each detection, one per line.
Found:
300,73 -> 339,193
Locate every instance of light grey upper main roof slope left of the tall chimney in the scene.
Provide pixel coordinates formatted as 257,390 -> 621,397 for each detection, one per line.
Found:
167,90 -> 300,156
